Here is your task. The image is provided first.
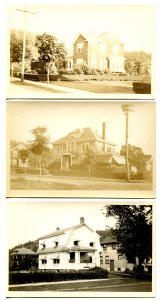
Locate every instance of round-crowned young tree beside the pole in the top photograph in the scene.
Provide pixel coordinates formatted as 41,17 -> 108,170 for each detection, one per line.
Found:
36,33 -> 66,84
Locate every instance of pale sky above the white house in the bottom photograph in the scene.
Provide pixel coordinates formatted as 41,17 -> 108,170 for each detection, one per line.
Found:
7,199 -> 116,249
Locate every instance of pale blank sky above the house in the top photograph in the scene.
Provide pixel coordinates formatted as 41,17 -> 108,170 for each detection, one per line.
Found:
8,1 -> 155,53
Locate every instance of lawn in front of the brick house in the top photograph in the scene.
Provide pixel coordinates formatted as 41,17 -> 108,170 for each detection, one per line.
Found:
51,81 -> 134,94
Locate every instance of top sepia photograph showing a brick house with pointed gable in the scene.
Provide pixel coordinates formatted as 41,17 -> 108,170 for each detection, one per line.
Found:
7,1 -> 155,99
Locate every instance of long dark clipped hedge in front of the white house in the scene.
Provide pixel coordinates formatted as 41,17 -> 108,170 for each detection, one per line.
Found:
9,268 -> 108,284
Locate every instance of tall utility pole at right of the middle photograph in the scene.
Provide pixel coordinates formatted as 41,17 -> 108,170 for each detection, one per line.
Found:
122,104 -> 134,182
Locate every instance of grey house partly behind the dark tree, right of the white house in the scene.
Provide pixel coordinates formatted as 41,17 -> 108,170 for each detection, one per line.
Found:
96,230 -> 128,272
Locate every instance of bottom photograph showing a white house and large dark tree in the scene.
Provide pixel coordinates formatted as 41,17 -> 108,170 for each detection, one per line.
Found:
7,200 -> 155,297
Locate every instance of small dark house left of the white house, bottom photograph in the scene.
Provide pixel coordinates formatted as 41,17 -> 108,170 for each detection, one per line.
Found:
10,247 -> 37,271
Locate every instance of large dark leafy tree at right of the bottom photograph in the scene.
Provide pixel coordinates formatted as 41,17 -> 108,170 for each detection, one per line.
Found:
104,205 -> 152,265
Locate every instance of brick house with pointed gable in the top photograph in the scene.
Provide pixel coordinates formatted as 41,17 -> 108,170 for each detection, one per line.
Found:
73,32 -> 125,73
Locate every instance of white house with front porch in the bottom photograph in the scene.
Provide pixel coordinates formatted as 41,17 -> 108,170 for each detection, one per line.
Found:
37,217 -> 101,270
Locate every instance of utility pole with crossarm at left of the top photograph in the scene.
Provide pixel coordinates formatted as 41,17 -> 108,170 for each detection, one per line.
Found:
16,6 -> 35,82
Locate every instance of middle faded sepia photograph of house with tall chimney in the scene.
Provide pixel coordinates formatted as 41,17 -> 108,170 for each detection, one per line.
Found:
7,101 -> 156,198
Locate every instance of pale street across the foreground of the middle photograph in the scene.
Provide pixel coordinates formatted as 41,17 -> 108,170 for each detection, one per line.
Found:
11,175 -> 152,191
